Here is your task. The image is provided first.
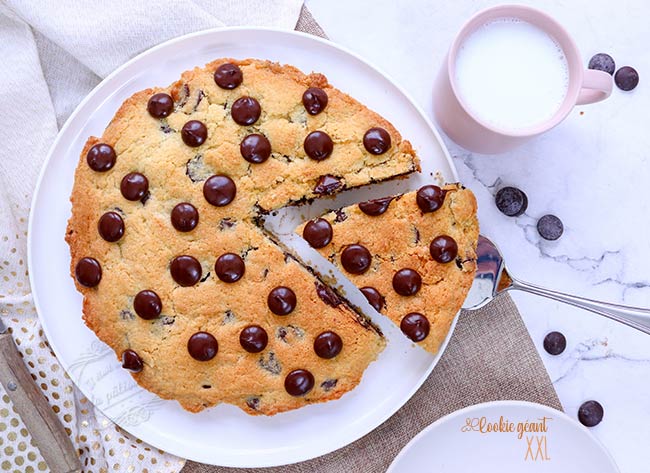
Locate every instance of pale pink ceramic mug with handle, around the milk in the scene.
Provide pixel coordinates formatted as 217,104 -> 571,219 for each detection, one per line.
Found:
433,5 -> 612,154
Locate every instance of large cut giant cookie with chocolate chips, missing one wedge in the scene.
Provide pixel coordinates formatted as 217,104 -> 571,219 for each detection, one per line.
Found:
66,59 -> 419,415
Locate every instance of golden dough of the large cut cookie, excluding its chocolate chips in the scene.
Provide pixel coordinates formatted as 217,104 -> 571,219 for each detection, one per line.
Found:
66,59 -> 419,415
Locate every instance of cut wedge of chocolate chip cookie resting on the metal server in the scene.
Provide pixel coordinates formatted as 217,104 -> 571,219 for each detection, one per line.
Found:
297,184 -> 479,353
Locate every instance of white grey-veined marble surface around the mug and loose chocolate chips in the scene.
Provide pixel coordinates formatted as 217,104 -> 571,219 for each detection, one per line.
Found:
307,0 -> 650,473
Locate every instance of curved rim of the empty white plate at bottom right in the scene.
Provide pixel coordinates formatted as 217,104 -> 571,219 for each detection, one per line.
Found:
386,401 -> 619,473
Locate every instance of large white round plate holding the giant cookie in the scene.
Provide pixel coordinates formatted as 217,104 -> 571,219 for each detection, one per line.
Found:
29,28 -> 456,467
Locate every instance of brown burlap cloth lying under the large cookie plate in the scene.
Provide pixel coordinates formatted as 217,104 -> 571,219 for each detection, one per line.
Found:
181,8 -> 562,473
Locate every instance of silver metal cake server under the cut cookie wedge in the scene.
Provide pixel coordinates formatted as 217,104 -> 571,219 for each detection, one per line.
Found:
463,235 -> 650,335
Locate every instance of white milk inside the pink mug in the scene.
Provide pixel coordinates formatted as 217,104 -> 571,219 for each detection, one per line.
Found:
455,18 -> 569,130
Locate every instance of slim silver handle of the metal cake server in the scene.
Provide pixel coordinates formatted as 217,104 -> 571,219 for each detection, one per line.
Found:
508,279 -> 650,335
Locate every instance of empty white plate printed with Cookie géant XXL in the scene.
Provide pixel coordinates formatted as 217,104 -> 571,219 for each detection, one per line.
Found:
386,401 -> 618,473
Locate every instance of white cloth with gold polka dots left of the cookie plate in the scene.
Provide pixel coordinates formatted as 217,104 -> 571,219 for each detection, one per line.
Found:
0,0 -> 302,473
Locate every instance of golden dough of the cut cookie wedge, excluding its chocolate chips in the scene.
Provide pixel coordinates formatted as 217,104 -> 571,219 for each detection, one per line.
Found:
297,184 -> 479,353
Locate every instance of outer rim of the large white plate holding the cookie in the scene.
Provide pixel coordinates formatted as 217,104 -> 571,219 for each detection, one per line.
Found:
27,27 -> 458,467
